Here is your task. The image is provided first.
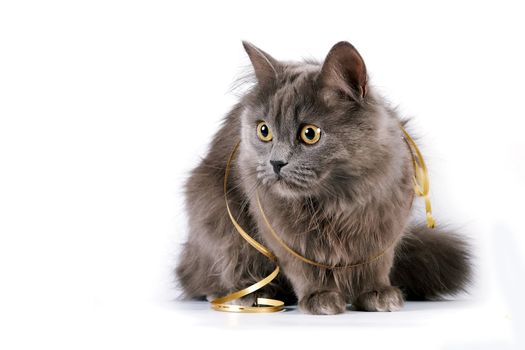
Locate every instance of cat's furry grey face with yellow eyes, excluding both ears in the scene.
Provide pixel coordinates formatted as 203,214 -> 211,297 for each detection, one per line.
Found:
241,64 -> 382,197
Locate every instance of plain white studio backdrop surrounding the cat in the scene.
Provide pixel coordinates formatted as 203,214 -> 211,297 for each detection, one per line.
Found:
0,0 -> 525,349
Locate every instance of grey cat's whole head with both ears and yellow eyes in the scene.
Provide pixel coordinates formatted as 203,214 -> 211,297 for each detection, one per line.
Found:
241,42 -> 391,196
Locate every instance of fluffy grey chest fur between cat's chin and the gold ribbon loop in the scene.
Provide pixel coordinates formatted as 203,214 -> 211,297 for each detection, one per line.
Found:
252,193 -> 406,265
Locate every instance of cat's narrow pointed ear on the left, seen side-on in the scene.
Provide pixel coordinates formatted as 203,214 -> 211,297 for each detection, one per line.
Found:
242,41 -> 281,88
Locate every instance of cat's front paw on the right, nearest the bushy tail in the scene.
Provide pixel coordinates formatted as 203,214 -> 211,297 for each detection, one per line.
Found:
352,286 -> 405,311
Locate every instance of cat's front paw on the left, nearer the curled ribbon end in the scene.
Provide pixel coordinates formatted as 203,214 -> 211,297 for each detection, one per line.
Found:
299,291 -> 346,315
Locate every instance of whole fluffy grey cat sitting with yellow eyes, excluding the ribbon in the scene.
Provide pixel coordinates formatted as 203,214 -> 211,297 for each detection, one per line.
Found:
176,42 -> 471,314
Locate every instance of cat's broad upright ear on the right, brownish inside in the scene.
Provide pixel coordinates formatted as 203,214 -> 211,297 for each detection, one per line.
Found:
320,41 -> 368,101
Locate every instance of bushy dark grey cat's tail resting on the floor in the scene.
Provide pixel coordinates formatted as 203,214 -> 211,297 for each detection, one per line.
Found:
390,225 -> 472,300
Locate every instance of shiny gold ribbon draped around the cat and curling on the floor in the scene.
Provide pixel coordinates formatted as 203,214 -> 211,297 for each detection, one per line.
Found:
211,126 -> 436,313
